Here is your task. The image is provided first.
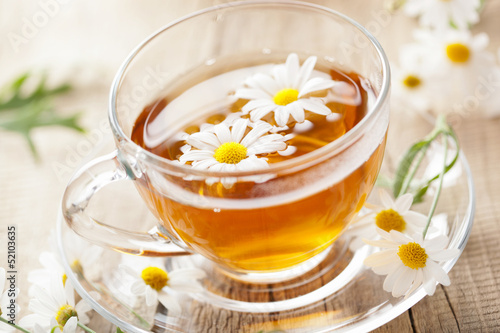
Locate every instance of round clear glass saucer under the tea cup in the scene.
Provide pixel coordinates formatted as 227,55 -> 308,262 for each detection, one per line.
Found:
57,113 -> 475,333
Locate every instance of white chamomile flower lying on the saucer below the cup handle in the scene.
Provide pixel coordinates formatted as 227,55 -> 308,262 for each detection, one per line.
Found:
120,261 -> 205,314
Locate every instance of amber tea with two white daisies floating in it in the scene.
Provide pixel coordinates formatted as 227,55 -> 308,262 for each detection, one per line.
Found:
131,54 -> 387,272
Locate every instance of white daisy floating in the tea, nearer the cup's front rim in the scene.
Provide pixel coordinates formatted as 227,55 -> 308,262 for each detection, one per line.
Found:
179,119 -> 290,188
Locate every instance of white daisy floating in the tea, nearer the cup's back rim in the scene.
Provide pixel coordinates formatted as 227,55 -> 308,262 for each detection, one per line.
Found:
235,53 -> 336,126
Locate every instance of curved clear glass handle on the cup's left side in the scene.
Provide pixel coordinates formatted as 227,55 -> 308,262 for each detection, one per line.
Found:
62,151 -> 192,256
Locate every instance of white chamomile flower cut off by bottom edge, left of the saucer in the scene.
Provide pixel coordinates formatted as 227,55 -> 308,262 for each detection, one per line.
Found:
19,274 -> 91,333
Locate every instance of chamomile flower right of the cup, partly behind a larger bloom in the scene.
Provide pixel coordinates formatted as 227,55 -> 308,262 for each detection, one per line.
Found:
346,190 -> 427,251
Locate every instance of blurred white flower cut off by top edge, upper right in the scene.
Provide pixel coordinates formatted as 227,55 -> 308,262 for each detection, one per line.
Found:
403,0 -> 481,30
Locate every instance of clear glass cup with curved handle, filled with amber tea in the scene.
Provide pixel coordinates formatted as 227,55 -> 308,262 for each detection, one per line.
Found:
63,1 -> 390,281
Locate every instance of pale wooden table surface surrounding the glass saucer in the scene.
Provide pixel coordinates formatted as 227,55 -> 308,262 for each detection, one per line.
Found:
0,0 -> 500,332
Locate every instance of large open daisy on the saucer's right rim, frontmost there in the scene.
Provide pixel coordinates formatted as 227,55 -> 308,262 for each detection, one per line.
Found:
364,229 -> 460,297
